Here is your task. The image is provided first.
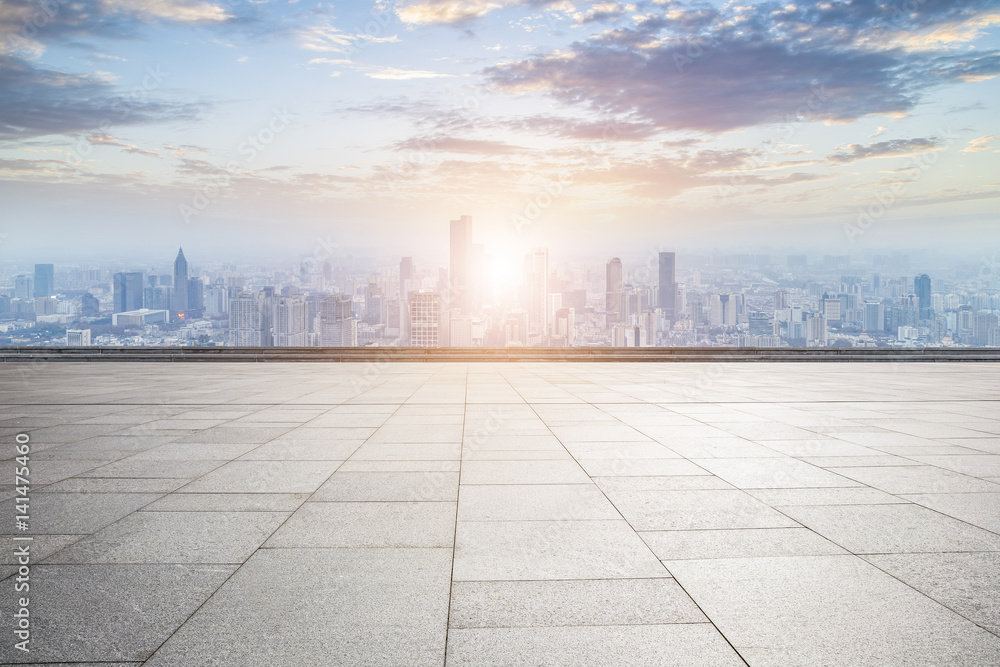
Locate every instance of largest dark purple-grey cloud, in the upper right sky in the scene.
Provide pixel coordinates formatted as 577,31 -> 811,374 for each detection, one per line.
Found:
484,0 -> 1000,133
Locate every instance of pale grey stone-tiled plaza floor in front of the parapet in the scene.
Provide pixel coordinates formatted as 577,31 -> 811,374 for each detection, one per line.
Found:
0,362 -> 1000,667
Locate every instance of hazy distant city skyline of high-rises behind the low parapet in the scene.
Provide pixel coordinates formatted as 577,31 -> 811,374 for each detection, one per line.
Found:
0,216 -> 1000,348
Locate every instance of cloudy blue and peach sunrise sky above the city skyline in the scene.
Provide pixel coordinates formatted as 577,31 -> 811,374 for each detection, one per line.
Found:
0,0 -> 1000,261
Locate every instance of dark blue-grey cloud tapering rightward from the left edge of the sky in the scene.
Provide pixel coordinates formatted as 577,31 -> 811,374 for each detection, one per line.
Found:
0,55 -> 202,140
